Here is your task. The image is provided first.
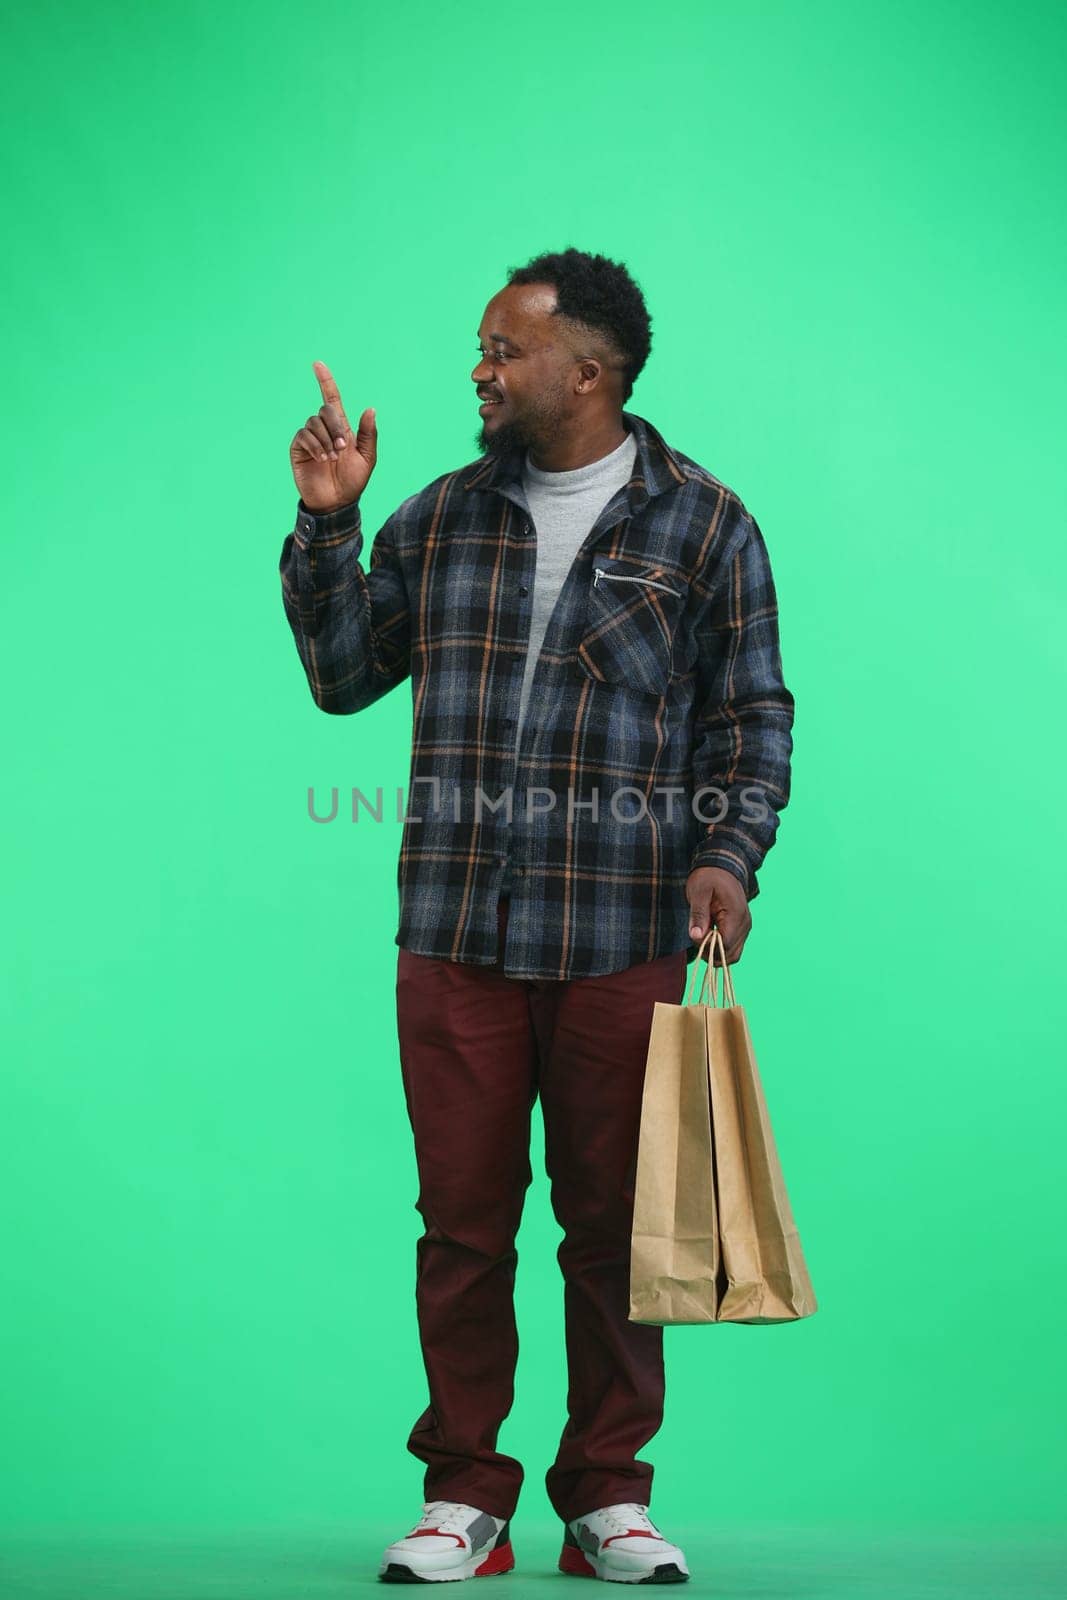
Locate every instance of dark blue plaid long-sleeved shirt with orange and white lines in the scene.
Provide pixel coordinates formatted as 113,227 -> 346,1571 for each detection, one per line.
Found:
278,411 -> 793,979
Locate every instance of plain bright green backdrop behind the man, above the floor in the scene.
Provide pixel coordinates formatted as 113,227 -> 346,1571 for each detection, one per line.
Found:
0,0 -> 1067,1594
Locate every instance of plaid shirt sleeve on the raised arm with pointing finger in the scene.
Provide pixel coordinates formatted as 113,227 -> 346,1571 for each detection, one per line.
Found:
278,486 -> 411,715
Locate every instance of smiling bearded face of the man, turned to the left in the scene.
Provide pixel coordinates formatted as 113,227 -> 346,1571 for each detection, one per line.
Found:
470,283 -> 577,456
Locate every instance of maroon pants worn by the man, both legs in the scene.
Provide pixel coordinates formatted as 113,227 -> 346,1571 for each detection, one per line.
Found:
397,899 -> 686,1522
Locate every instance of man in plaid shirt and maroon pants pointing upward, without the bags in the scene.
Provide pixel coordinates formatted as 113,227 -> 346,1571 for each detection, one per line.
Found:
280,250 -> 793,1582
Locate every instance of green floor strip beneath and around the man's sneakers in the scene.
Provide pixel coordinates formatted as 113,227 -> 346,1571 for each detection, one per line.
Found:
0,1522 -> 1067,1600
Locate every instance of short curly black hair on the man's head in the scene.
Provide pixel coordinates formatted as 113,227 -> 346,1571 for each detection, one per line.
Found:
507,248 -> 653,403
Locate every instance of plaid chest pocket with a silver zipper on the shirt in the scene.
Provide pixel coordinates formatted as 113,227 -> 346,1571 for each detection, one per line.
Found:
577,552 -> 686,694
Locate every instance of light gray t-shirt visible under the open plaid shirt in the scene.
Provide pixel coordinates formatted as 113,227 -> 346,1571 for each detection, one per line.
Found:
501,432 -> 637,894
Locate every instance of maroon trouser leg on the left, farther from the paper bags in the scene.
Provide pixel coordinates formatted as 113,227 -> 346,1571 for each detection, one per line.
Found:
397,901 -> 537,1517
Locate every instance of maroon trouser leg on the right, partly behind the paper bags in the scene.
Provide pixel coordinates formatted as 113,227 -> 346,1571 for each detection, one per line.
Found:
533,950 -> 686,1522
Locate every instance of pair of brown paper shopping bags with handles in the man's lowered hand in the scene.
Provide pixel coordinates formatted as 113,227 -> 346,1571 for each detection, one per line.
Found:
629,928 -> 817,1325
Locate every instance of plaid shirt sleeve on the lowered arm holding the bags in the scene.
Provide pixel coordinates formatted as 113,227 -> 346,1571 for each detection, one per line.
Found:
689,514 -> 795,901
